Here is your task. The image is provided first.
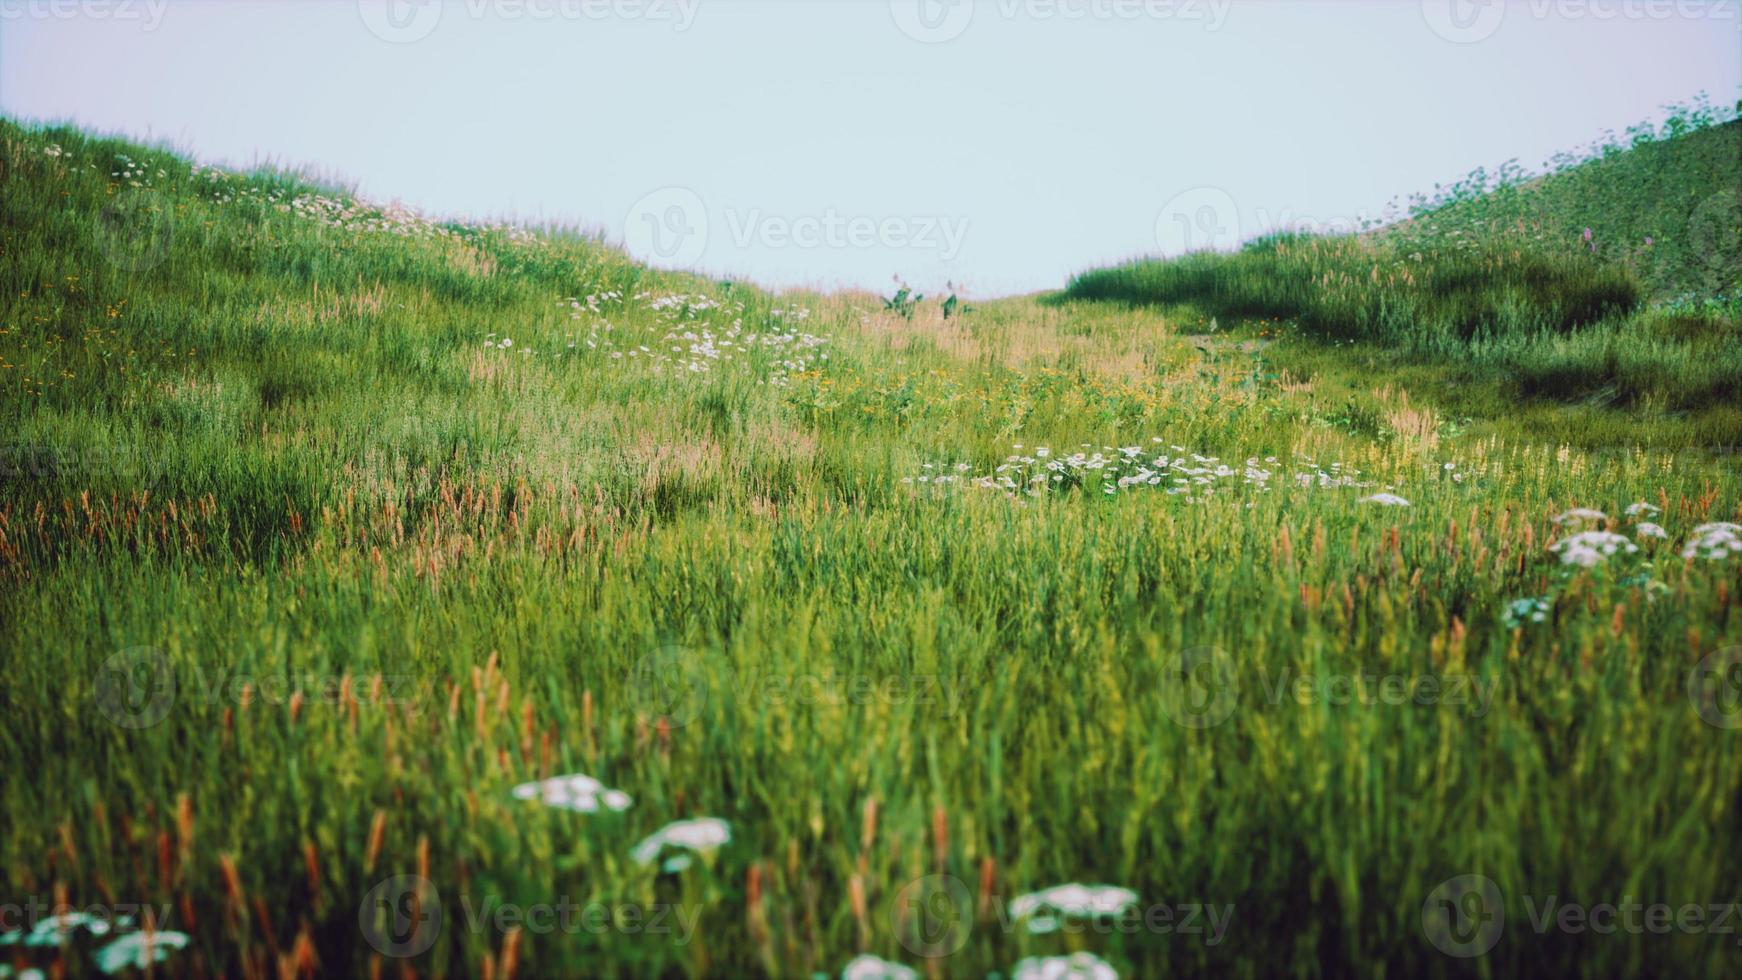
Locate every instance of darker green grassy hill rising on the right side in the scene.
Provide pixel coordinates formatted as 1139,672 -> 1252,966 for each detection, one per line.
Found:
1066,103 -> 1742,436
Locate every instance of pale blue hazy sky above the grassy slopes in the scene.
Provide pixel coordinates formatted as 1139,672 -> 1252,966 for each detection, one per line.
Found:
0,0 -> 1742,298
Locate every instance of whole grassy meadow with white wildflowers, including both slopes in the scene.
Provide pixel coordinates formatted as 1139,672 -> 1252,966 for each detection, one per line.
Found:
0,101 -> 1742,980
